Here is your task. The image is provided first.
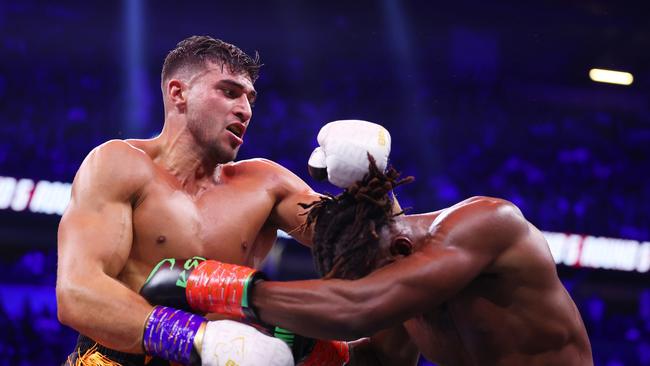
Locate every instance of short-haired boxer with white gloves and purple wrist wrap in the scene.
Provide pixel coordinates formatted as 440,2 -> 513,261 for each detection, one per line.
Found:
56,36 -> 390,366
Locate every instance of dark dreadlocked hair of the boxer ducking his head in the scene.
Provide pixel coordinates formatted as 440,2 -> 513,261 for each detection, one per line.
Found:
300,154 -> 414,279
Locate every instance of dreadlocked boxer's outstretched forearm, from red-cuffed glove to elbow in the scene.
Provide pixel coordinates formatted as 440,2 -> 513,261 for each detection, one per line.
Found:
251,252 -> 442,340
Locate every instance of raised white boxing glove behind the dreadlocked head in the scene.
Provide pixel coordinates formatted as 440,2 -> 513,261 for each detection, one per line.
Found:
308,120 -> 390,188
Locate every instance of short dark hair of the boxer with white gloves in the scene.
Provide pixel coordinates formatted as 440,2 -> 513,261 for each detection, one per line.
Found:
161,36 -> 262,83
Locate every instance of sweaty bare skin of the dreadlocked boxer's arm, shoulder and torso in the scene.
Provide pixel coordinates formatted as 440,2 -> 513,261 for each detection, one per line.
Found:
253,197 -> 593,366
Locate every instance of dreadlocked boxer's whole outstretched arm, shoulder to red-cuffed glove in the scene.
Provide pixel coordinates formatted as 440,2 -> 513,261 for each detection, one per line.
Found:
253,199 -> 529,340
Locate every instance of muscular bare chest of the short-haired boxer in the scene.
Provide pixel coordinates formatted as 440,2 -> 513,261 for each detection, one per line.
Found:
131,176 -> 275,266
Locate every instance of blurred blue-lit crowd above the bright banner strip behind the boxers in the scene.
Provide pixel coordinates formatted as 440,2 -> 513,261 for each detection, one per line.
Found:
0,34 -> 650,240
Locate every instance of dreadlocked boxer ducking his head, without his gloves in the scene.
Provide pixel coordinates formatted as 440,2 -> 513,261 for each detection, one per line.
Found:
144,156 -> 593,366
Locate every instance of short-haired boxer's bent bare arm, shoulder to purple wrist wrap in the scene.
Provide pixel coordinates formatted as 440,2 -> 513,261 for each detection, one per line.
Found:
56,141 -> 152,353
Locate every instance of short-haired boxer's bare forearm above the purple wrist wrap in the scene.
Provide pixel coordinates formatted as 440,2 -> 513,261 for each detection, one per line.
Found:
57,274 -> 152,353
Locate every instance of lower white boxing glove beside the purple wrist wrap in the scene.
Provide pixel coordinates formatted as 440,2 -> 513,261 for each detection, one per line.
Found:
201,320 -> 294,366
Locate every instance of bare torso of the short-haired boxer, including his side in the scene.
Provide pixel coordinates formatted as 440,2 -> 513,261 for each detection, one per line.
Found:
117,141 -> 288,291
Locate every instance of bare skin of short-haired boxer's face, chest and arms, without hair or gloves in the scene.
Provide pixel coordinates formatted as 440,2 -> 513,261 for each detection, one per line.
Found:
56,62 -> 318,353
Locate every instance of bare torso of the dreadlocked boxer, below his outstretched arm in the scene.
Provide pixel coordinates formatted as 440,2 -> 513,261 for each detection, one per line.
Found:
404,207 -> 592,366
